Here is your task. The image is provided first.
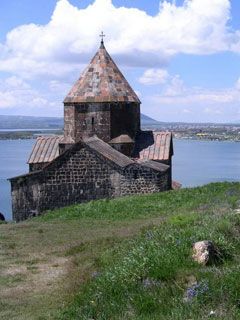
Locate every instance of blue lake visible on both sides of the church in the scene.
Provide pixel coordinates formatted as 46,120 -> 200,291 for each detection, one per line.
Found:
0,140 -> 240,220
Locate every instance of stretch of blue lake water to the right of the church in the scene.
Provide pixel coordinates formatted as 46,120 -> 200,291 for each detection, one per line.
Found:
173,140 -> 240,187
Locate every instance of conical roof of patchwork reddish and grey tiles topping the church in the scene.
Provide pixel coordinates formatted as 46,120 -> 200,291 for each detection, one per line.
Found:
64,41 -> 140,103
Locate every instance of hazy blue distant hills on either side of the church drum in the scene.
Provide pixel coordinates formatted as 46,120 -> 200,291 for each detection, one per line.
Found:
0,114 -> 158,129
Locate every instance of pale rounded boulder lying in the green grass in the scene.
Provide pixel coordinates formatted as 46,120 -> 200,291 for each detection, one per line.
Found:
192,240 -> 219,265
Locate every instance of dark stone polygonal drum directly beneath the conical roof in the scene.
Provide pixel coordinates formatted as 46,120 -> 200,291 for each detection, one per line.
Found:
64,102 -> 140,142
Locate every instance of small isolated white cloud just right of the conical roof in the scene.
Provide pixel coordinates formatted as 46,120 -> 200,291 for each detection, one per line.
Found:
139,69 -> 169,85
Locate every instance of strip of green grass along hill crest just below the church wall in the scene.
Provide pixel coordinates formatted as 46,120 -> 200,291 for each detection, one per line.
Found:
38,183 -> 239,221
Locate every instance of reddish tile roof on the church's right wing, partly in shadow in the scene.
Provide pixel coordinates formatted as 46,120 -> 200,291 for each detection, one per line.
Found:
134,131 -> 173,161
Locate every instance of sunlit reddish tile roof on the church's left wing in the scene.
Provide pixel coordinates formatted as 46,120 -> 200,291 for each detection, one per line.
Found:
28,136 -> 63,164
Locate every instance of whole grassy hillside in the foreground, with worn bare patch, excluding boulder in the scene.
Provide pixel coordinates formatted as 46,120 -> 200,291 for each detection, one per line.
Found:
0,183 -> 240,320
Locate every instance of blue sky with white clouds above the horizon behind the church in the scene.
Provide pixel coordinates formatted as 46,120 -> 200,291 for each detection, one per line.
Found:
0,0 -> 240,123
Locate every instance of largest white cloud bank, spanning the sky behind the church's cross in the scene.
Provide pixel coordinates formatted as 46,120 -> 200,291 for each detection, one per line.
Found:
0,0 -> 240,77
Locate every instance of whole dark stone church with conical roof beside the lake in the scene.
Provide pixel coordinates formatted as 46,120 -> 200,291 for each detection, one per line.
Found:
10,40 -> 173,221
